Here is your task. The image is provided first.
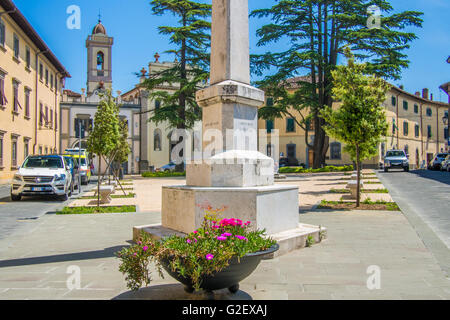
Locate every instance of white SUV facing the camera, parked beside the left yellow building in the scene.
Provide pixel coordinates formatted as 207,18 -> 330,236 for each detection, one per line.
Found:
11,155 -> 72,201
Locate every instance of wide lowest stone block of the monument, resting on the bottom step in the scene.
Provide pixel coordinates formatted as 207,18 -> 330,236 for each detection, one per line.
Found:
162,185 -> 299,235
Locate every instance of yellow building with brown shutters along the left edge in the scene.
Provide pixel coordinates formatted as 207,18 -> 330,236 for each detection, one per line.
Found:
0,0 -> 70,183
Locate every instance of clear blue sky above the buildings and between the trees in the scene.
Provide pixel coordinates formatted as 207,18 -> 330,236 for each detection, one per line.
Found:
14,0 -> 450,101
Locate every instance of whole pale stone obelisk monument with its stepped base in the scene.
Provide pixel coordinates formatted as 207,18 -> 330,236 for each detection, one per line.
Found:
134,0 -> 326,254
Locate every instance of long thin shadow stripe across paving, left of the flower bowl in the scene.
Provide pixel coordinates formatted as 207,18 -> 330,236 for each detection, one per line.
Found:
0,246 -> 127,268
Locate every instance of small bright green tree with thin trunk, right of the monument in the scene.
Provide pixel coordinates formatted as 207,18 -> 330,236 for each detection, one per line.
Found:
322,48 -> 390,207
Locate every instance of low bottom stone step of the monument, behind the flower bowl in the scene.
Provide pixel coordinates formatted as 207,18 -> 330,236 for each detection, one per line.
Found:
133,223 -> 327,259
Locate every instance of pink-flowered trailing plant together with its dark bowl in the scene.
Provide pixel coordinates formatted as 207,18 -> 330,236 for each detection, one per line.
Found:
118,203 -> 279,293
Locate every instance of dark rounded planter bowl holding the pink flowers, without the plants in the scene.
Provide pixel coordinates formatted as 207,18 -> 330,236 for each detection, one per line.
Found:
160,244 -> 279,293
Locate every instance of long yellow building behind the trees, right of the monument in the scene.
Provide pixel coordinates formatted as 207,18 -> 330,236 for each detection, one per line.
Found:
258,78 -> 448,169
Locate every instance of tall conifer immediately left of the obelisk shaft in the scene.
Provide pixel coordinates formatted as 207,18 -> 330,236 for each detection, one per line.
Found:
143,0 -> 211,171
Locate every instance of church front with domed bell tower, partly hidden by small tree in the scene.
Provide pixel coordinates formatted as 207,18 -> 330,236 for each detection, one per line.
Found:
60,20 -> 141,174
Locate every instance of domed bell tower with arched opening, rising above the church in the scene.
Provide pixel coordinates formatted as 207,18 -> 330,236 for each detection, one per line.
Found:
86,19 -> 114,95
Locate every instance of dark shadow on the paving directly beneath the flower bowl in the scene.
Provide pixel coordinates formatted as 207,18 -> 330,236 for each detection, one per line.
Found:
113,284 -> 253,300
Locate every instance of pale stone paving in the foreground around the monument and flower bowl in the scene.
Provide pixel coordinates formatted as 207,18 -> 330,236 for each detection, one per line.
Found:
0,211 -> 450,300
